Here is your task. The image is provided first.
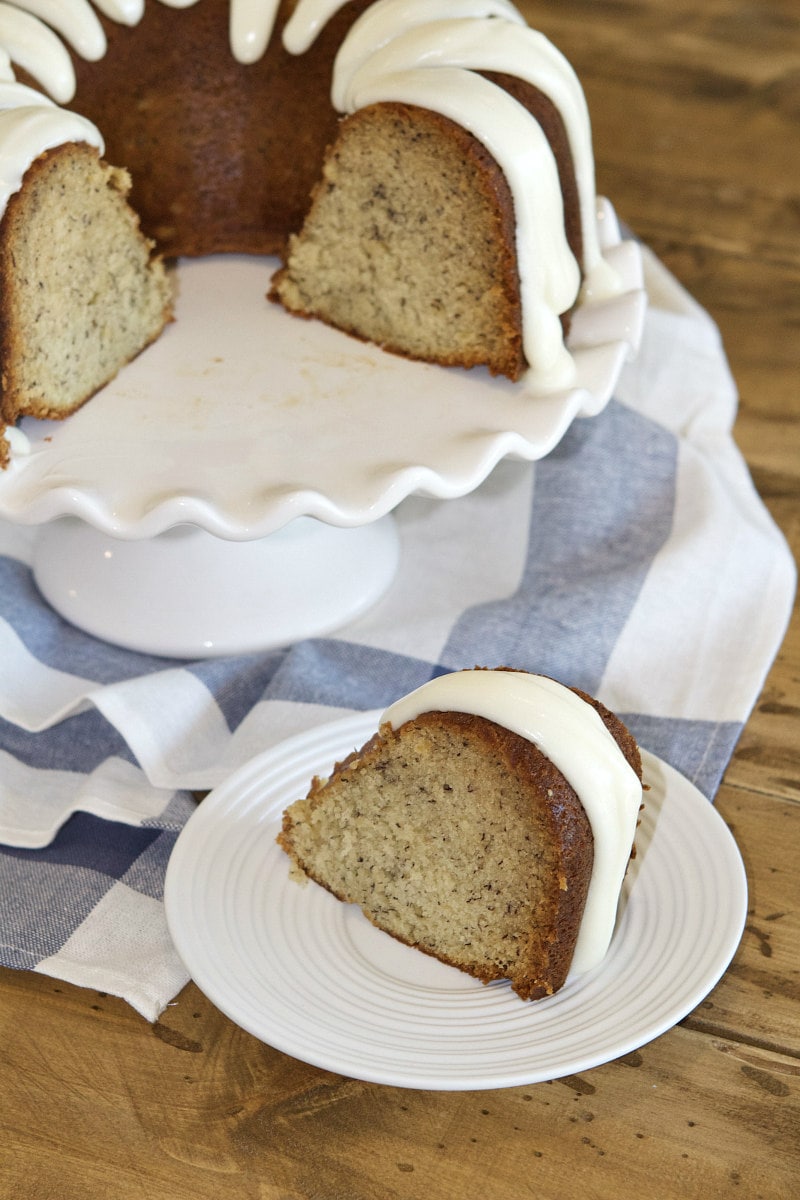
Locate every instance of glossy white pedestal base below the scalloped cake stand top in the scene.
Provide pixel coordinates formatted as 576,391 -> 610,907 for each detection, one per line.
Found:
34,516 -> 399,659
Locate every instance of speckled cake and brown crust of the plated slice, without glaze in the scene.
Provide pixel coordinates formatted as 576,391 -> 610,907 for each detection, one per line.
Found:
278,692 -> 642,1000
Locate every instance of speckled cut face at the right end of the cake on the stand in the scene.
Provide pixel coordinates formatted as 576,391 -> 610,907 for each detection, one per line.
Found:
272,103 -> 523,377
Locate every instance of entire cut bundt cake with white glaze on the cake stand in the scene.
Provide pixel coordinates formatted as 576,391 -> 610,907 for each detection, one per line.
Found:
0,0 -> 619,458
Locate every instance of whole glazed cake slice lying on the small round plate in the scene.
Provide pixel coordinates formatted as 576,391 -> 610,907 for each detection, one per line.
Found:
278,671 -> 642,1000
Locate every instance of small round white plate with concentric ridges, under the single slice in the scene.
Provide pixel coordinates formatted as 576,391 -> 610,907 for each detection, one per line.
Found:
166,713 -> 747,1091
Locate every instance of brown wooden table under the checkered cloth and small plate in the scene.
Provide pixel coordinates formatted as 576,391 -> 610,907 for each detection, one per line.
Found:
0,0 -> 800,1200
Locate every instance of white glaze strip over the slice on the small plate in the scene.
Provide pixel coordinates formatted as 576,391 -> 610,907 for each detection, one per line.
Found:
380,671 -> 642,978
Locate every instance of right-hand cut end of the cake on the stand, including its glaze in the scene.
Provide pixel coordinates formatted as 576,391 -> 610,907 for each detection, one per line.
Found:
270,0 -> 620,392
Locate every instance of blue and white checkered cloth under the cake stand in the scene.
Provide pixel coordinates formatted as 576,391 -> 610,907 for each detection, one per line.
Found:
0,253 -> 795,1020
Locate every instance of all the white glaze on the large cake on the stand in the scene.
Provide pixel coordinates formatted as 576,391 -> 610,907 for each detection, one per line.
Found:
0,0 -> 619,390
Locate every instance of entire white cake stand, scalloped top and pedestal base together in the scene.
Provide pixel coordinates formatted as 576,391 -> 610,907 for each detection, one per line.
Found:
0,202 -> 645,658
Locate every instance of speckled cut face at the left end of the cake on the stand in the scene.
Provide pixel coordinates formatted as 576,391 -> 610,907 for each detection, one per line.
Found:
0,142 -> 172,425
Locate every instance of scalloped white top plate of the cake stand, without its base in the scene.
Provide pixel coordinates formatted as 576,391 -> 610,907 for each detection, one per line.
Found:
0,202 -> 645,541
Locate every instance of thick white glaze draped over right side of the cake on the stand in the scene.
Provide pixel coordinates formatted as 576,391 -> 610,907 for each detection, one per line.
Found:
283,0 -> 620,389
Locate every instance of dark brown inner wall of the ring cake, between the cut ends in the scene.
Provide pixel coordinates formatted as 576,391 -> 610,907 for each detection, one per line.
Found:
59,0 -> 367,257
